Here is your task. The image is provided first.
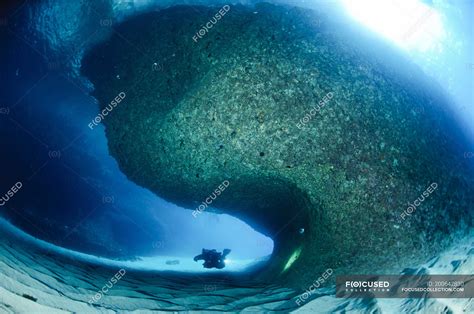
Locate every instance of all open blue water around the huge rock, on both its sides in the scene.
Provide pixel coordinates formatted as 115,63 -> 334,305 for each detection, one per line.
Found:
0,0 -> 474,272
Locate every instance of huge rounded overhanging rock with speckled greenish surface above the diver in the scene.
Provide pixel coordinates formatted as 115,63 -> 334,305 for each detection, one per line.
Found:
83,4 -> 474,286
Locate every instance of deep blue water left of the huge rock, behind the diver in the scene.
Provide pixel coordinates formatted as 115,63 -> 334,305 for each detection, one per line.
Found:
0,2 -> 273,268
